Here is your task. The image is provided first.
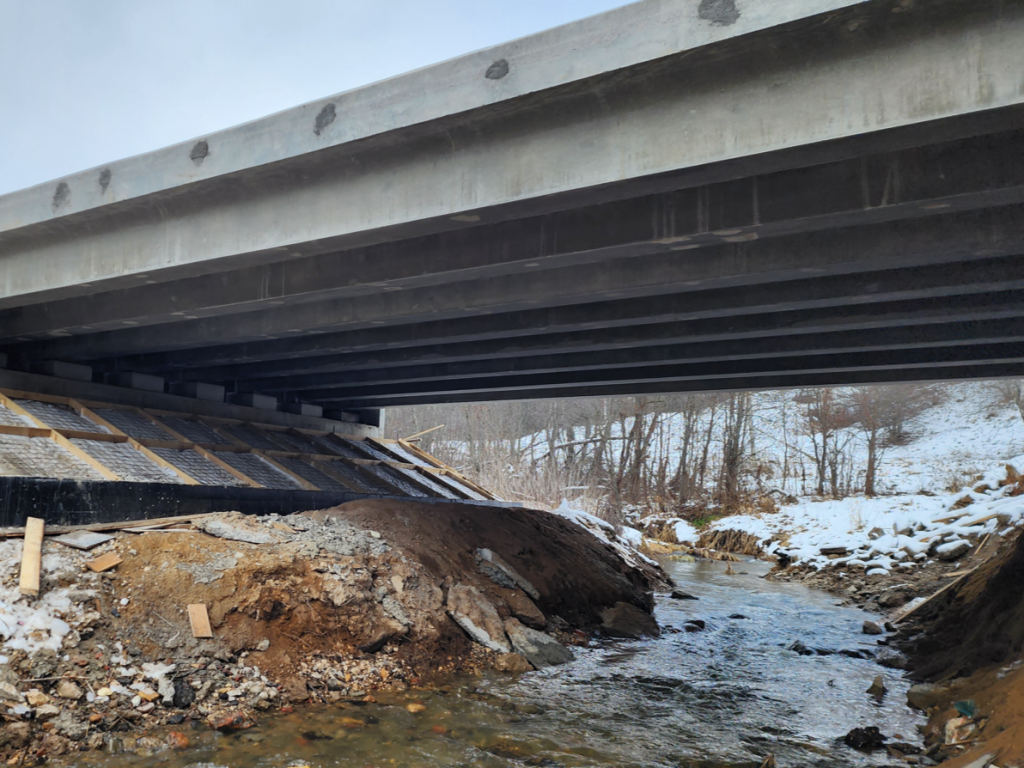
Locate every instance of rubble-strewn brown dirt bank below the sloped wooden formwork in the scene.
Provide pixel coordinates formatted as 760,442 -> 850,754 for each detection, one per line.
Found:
0,500 -> 665,765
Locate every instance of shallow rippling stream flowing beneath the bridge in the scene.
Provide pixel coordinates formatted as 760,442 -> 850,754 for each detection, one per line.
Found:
79,562 -> 923,768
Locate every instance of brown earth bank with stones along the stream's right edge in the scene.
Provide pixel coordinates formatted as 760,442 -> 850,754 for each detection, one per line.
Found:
770,532 -> 1024,768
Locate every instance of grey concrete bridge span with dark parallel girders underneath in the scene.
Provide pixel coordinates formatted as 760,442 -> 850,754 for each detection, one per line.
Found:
0,0 -> 1024,421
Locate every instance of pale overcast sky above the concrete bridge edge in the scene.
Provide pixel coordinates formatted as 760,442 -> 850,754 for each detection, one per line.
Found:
0,0 -> 625,195
